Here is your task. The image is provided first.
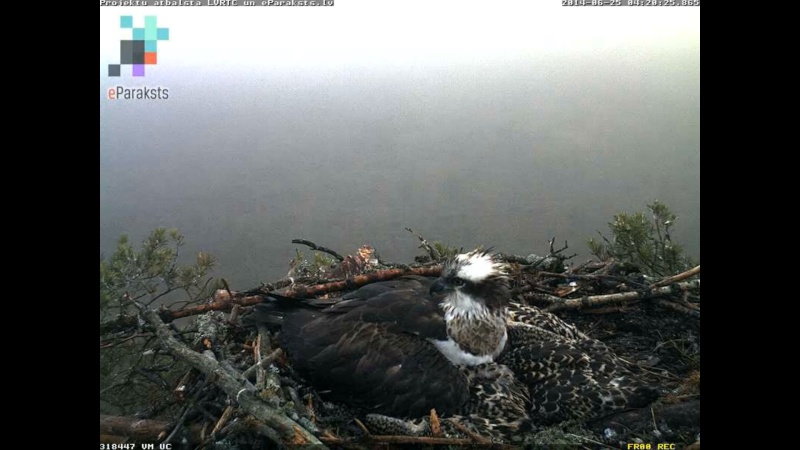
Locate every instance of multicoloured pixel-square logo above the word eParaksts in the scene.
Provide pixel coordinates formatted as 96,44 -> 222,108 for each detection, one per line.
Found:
108,16 -> 169,77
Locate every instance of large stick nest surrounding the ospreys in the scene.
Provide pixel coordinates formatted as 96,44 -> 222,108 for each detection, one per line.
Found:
100,238 -> 700,449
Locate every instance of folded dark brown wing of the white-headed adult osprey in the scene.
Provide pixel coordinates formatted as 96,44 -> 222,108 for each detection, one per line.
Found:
281,313 -> 469,417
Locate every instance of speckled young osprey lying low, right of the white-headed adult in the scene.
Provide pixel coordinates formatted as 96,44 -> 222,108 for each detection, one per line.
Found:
498,302 -> 658,424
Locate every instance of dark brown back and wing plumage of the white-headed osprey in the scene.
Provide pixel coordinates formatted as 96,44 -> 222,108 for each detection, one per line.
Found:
280,277 -> 469,417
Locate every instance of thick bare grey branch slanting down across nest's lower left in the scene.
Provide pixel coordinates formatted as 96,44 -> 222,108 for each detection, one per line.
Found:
136,303 -> 323,447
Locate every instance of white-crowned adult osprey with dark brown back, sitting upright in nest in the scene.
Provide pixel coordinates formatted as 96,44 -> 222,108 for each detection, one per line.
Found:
250,250 -> 509,417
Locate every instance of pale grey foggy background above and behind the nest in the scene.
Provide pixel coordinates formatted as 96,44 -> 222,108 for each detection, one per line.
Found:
100,0 -> 700,289
